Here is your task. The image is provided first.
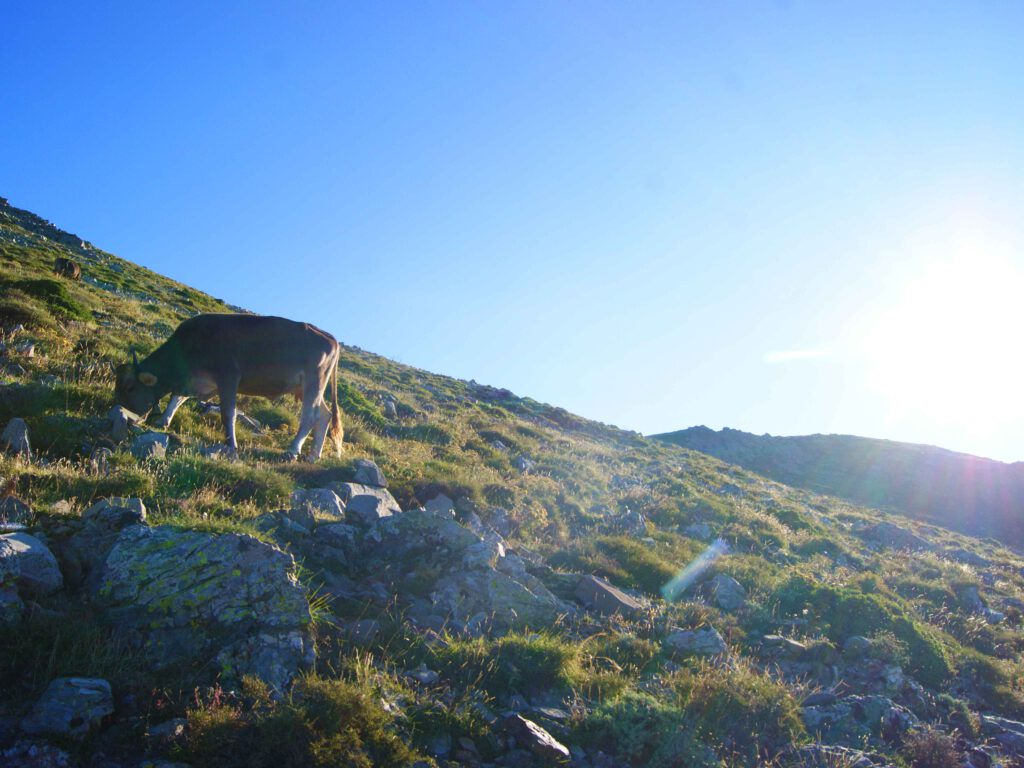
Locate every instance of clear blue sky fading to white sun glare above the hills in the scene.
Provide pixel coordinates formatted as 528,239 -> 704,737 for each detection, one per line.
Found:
0,0 -> 1024,461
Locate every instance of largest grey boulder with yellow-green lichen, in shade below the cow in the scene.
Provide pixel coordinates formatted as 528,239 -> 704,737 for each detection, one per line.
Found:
93,525 -> 310,685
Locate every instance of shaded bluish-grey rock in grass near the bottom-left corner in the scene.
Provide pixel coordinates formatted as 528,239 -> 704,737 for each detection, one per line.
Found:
22,677 -> 114,738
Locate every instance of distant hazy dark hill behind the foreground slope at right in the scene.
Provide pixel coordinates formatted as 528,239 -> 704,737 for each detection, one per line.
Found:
653,427 -> 1024,547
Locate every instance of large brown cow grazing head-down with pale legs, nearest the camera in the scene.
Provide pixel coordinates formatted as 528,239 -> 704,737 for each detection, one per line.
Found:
114,314 -> 344,462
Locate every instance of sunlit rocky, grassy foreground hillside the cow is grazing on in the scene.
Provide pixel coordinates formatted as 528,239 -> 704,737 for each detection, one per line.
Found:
0,199 -> 1024,768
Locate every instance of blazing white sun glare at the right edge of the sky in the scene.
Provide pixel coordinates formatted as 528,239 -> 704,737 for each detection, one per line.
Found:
861,252 -> 1024,435
